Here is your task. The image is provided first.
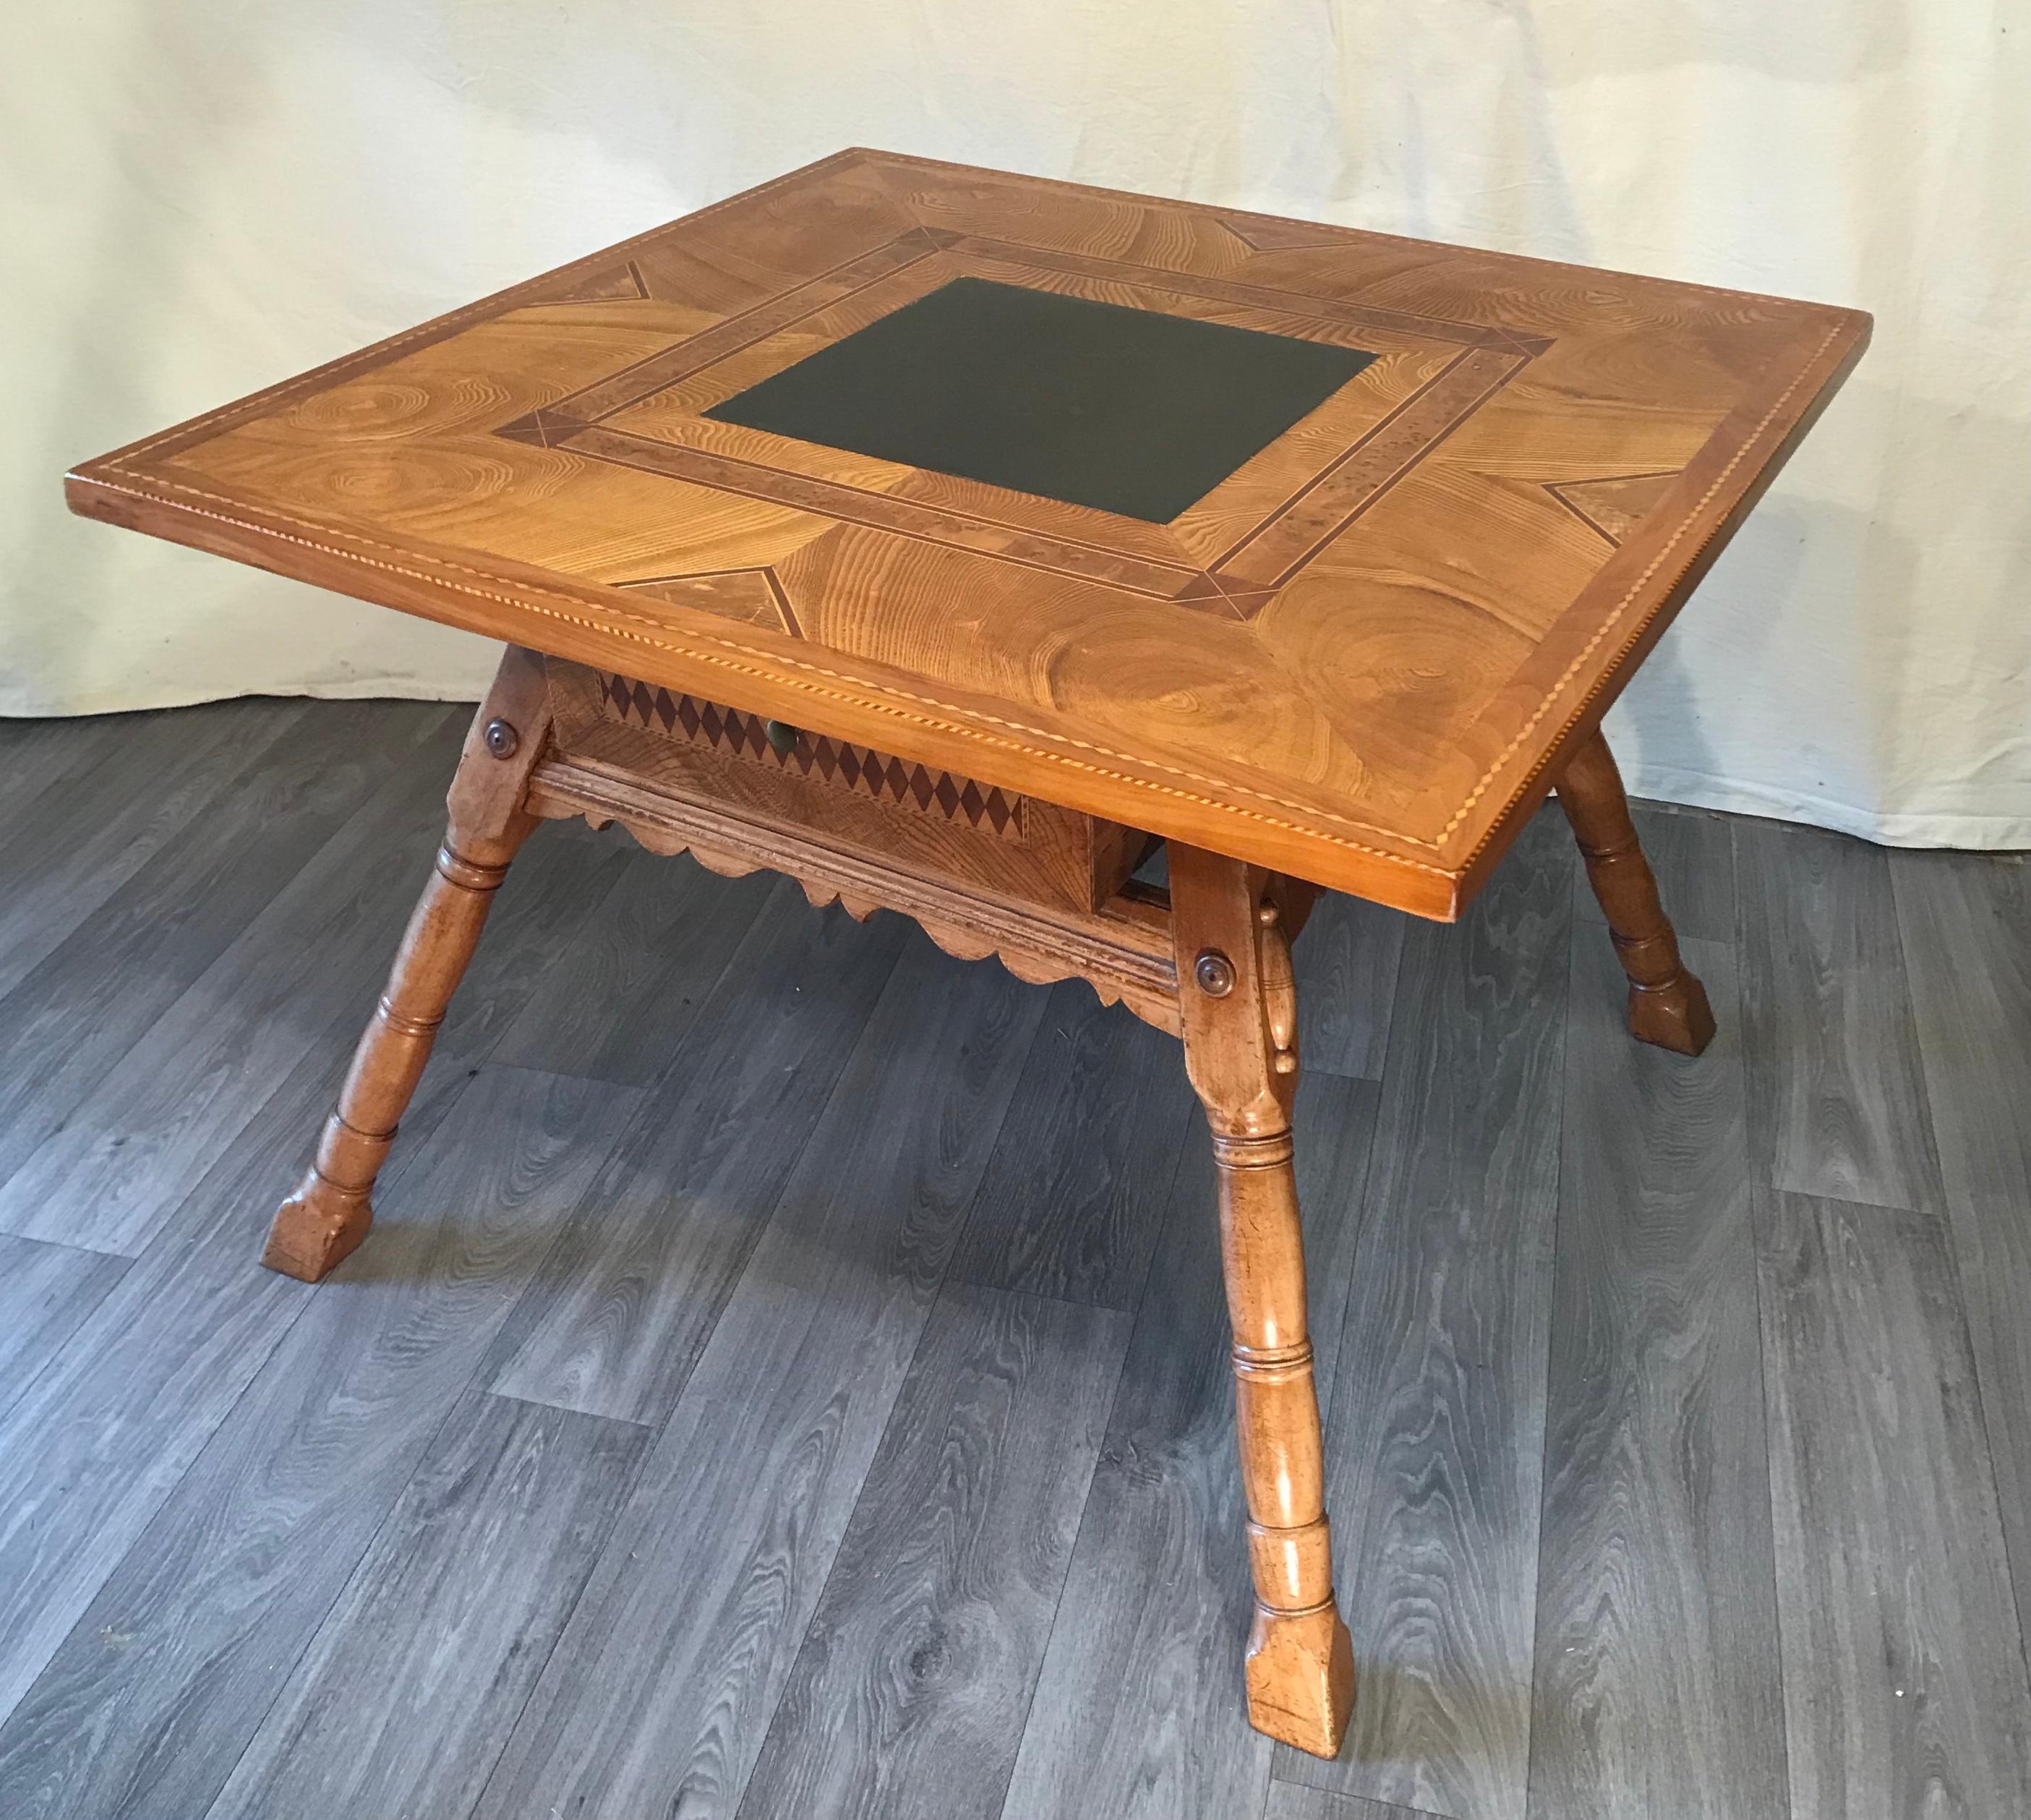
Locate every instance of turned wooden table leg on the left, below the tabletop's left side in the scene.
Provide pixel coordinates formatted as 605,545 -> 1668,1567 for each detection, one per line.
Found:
262,648 -> 548,1283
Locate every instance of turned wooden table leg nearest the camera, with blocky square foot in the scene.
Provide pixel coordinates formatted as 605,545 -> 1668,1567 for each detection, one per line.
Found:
1170,843 -> 1355,1757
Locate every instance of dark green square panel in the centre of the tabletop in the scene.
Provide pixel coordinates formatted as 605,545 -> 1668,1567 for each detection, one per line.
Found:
705,278 -> 1375,524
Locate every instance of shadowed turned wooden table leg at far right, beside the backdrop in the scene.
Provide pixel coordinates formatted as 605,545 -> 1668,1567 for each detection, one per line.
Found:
1558,731 -> 1714,1056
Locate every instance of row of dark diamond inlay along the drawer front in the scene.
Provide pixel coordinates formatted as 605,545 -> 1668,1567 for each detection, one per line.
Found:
595,670 -> 1024,841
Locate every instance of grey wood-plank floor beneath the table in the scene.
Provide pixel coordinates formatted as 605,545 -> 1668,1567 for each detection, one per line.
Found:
0,701 -> 2031,1820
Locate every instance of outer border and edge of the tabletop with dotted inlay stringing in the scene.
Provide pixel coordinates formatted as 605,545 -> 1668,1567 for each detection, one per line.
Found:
65,146 -> 1870,918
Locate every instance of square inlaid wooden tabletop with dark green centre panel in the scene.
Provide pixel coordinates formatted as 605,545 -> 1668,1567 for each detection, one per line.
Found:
67,150 -> 1868,916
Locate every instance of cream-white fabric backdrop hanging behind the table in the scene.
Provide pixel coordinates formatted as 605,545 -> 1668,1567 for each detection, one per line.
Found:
0,0 -> 2031,847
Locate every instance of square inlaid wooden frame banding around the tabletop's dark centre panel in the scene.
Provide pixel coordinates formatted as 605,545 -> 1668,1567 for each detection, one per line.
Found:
495,228 -> 1552,622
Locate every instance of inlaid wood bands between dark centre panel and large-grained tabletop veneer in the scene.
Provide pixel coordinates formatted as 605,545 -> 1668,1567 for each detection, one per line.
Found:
494,229 -> 1554,623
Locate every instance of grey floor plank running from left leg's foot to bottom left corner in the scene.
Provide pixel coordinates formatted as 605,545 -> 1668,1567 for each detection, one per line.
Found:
0,1069 -> 633,1820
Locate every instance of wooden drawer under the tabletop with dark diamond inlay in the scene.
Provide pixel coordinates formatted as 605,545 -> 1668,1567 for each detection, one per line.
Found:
547,658 -> 1150,910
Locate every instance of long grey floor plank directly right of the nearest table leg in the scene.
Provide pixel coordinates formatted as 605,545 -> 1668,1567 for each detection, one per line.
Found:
1275,813 -> 1574,1820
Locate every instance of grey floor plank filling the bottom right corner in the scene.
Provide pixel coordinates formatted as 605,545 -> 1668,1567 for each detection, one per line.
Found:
1759,1192 -> 2031,1820
